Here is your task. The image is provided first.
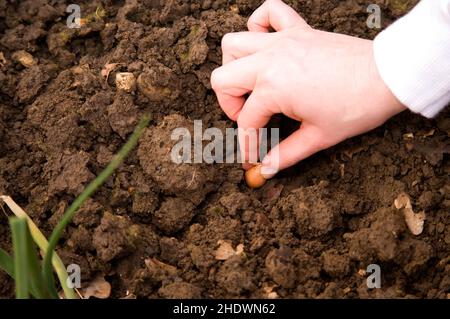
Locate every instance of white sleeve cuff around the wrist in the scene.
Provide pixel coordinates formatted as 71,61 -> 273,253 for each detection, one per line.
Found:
374,0 -> 450,117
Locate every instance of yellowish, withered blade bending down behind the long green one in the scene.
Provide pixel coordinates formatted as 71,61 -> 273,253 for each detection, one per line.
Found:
0,196 -> 78,299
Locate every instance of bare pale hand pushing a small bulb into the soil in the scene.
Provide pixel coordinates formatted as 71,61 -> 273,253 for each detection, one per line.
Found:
211,0 -> 405,178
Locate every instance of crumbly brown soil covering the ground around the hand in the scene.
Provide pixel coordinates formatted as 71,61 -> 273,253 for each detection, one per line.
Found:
0,0 -> 450,298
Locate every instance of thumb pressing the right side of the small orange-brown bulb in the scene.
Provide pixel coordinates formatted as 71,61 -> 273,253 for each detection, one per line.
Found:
261,124 -> 327,179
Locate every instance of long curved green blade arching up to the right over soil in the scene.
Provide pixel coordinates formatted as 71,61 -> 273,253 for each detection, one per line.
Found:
43,116 -> 150,293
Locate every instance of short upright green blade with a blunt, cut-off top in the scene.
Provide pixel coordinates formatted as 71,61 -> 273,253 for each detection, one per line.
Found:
9,217 -> 29,299
